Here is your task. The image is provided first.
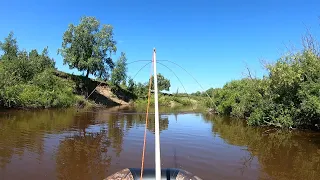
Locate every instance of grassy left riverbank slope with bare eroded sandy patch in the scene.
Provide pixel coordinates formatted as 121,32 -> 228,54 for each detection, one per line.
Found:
0,64 -> 134,109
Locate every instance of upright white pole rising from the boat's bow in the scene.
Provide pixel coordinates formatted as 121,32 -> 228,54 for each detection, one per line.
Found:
153,48 -> 161,180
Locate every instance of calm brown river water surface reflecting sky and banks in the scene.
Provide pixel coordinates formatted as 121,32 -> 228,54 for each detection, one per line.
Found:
0,108 -> 320,180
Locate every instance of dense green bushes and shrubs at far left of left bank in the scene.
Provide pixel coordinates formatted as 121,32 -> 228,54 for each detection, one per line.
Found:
0,34 -> 75,108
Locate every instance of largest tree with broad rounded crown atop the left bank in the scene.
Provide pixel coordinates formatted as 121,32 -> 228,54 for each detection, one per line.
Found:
58,17 -> 117,78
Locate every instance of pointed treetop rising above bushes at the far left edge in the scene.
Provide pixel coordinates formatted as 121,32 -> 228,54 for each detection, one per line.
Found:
0,32 -> 18,60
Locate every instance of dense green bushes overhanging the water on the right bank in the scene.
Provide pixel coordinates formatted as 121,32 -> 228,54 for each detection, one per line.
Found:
213,50 -> 320,127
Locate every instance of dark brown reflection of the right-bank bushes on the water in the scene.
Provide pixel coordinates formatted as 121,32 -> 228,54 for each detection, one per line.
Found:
205,116 -> 320,179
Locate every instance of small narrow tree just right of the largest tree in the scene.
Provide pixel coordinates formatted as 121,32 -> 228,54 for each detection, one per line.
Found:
111,52 -> 127,85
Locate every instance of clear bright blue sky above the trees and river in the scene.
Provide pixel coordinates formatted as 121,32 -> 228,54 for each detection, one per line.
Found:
0,0 -> 320,93
